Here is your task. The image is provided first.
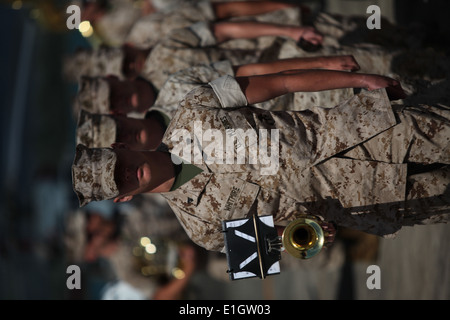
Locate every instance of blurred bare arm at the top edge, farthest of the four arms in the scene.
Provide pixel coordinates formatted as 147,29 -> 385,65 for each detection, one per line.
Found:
212,1 -> 298,19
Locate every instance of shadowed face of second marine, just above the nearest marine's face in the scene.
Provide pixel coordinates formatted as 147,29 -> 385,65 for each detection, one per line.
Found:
114,116 -> 154,150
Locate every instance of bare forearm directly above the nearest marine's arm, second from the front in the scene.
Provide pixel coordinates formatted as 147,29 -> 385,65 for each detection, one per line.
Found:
233,55 -> 359,77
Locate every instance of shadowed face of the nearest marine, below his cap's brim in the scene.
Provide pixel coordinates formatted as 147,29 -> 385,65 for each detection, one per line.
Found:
114,149 -> 152,197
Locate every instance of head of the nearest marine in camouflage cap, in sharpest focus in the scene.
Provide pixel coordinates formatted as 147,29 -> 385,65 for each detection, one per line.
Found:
72,144 -> 167,206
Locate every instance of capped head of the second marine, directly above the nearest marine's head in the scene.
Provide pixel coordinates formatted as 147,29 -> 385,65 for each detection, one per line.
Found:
76,110 -> 164,150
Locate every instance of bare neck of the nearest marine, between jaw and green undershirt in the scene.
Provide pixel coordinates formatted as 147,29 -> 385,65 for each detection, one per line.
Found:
147,151 -> 175,193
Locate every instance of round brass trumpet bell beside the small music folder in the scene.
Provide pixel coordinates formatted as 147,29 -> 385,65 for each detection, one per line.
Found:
281,218 -> 325,259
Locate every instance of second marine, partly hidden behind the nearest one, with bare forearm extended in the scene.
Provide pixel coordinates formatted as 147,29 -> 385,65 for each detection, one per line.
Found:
76,57 -> 358,154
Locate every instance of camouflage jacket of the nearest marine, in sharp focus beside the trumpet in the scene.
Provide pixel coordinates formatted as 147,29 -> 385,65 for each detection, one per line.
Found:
162,76 -> 406,251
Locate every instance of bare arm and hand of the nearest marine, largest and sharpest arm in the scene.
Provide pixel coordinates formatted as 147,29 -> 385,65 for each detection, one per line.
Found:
236,70 -> 404,104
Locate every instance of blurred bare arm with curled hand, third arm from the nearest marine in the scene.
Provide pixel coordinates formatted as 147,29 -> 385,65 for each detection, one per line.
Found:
212,21 -> 323,45
